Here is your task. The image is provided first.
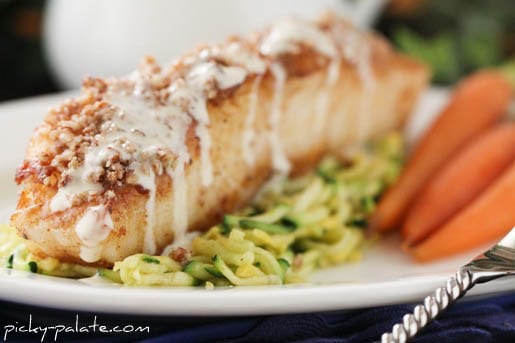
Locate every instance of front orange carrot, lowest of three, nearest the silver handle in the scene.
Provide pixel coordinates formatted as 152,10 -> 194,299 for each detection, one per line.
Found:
408,163 -> 515,262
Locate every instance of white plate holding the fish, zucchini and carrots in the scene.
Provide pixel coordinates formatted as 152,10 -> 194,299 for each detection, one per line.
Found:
0,89 -> 515,316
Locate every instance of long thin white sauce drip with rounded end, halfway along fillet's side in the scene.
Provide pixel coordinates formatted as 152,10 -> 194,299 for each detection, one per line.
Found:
268,63 -> 291,174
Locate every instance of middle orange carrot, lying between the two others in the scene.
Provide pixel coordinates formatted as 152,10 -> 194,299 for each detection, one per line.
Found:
402,123 -> 515,245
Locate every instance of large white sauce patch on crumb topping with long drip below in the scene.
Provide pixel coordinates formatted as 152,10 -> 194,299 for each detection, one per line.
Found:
86,93 -> 191,254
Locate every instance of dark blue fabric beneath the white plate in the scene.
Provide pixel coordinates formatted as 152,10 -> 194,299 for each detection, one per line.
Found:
0,293 -> 515,343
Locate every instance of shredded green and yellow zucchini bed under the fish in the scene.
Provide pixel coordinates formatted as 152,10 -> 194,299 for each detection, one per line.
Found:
0,133 -> 404,288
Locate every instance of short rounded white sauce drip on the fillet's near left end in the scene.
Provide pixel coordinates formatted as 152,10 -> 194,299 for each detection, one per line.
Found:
75,205 -> 113,263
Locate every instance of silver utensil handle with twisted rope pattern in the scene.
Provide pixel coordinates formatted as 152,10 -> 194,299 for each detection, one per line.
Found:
381,227 -> 515,343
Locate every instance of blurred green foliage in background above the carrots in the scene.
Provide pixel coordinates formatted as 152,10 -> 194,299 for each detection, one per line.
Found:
377,0 -> 515,84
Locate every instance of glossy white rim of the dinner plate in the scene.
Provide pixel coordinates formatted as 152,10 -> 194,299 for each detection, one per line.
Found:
0,88 -> 515,316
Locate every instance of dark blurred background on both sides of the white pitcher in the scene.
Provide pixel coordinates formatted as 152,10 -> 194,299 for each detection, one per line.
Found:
0,0 -> 515,101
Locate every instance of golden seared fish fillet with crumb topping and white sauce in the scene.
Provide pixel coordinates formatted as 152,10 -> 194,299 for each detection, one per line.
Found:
11,14 -> 428,266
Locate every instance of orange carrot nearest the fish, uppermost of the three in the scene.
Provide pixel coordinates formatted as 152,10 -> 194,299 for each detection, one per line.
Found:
371,71 -> 512,231
